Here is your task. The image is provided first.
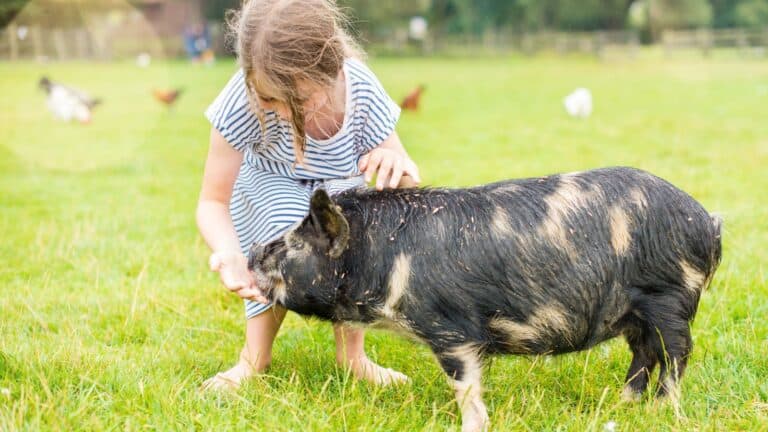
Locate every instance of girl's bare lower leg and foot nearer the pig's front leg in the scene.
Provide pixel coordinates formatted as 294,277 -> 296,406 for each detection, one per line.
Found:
333,324 -> 408,385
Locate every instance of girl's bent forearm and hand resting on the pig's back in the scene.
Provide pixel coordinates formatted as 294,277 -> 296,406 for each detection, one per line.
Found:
359,132 -> 421,190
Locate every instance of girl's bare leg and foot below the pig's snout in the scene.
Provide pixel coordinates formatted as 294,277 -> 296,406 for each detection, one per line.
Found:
203,305 -> 285,390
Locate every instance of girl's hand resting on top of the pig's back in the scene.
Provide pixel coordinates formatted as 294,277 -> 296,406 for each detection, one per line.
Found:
359,147 -> 421,190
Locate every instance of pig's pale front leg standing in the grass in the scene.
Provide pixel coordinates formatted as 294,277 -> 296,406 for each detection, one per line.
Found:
436,343 -> 488,432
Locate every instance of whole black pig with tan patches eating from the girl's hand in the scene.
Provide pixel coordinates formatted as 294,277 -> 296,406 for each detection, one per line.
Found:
249,167 -> 722,432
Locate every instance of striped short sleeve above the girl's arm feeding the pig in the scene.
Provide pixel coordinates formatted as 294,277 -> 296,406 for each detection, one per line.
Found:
205,69 -> 261,152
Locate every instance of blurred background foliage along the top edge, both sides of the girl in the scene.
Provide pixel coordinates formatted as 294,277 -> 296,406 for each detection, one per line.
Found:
0,0 -> 768,39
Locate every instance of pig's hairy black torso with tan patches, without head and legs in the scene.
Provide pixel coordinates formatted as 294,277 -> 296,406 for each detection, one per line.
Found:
340,168 -> 719,353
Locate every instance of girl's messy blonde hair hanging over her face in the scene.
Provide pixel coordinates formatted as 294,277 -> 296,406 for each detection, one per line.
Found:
229,0 -> 363,164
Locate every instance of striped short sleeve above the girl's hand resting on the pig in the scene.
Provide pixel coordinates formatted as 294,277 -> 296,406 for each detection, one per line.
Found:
355,63 -> 400,154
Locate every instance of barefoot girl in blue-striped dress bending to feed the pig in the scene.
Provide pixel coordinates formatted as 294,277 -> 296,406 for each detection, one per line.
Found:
197,0 -> 419,388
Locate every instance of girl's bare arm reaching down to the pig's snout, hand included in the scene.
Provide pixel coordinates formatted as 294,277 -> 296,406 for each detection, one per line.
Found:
197,129 -> 263,301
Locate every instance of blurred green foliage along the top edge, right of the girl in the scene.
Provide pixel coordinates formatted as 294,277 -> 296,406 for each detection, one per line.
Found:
343,0 -> 752,34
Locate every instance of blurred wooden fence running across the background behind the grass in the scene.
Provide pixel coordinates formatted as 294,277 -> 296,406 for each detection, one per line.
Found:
6,23 -> 768,61
